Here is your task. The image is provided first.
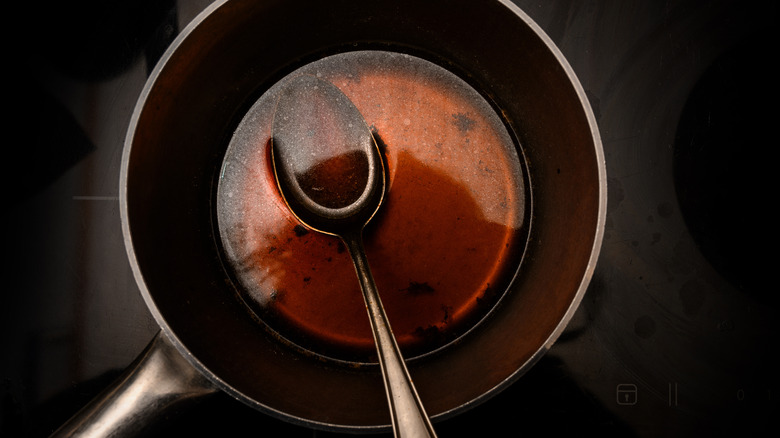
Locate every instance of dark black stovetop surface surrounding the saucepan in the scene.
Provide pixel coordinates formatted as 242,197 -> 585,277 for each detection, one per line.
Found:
0,0 -> 778,437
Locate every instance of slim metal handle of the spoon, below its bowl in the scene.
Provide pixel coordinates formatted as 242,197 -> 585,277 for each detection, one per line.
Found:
342,232 -> 436,438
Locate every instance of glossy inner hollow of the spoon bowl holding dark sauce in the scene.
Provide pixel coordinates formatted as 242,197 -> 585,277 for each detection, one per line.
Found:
271,74 -> 381,215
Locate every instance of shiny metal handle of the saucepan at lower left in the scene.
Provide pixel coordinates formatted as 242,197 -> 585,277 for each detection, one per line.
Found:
51,331 -> 218,438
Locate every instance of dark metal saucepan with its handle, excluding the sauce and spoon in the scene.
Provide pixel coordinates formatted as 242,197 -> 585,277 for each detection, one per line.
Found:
57,0 -> 606,436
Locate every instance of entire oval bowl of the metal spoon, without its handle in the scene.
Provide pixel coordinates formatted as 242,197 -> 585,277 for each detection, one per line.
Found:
271,75 -> 385,235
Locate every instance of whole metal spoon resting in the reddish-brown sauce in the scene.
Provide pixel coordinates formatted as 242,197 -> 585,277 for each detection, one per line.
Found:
271,75 -> 436,437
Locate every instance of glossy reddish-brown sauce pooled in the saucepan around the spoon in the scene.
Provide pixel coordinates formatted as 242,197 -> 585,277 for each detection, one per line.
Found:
217,51 -> 530,362
